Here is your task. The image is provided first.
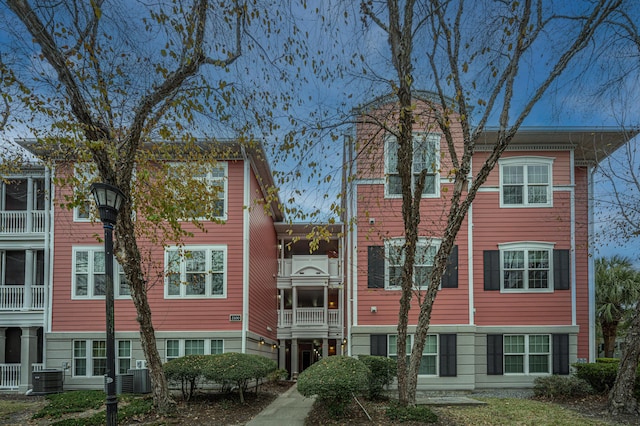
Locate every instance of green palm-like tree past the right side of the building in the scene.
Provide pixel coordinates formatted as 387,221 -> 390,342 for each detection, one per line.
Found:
596,256 -> 640,358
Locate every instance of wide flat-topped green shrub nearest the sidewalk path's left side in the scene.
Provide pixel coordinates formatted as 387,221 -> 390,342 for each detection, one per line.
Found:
203,352 -> 277,403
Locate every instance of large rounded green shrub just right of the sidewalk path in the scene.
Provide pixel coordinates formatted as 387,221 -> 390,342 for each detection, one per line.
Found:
298,356 -> 369,417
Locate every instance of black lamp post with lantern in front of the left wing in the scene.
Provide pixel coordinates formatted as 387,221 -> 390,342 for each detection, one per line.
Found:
91,183 -> 124,426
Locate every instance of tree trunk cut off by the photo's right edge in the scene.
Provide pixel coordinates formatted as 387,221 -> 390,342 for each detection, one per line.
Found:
607,304 -> 640,415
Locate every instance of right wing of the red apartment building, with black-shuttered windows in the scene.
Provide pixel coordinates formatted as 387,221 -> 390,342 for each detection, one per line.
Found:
344,94 -> 627,390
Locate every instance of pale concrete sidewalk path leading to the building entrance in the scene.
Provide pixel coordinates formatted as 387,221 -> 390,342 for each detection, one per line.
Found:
247,383 -> 315,426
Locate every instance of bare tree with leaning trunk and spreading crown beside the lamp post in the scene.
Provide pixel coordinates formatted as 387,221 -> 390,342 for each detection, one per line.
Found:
3,0 -> 246,412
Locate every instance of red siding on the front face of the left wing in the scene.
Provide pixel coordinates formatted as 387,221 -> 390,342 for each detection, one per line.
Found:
52,162 -> 254,332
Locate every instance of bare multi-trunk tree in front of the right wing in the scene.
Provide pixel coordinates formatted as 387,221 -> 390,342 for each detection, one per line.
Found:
361,0 -> 623,405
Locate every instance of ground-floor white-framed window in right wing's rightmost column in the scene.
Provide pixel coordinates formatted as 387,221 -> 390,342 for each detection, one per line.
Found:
503,334 -> 551,374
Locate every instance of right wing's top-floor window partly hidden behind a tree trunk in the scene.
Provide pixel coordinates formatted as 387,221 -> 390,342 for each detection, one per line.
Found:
384,132 -> 440,197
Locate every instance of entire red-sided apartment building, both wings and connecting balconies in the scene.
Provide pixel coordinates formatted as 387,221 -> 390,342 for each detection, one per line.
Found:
0,97 -> 627,390
